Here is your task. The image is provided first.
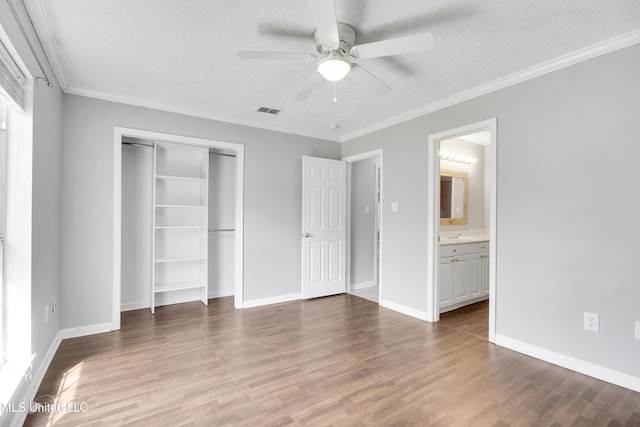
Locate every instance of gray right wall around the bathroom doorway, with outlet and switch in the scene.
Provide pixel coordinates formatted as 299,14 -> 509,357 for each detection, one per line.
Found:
343,45 -> 640,377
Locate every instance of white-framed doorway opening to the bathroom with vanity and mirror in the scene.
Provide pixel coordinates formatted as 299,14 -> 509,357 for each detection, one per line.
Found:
427,119 -> 497,342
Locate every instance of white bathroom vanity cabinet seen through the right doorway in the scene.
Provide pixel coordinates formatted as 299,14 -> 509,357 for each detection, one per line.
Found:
439,241 -> 489,313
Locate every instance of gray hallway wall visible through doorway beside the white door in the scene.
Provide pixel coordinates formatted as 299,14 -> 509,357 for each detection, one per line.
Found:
349,157 -> 380,287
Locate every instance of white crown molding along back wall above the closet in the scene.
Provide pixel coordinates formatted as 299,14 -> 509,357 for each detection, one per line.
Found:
64,86 -> 342,142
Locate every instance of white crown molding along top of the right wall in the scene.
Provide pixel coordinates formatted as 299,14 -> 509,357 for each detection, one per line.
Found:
341,30 -> 640,142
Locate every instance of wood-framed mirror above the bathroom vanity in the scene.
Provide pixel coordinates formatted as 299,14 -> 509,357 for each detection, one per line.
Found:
440,169 -> 469,225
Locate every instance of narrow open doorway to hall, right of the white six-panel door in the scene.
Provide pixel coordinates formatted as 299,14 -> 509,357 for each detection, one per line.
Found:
344,150 -> 382,303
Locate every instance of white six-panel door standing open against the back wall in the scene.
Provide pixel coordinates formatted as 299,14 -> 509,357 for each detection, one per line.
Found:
302,156 -> 347,298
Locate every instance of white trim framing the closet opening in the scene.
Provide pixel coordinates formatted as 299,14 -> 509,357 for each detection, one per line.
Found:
111,126 -> 244,330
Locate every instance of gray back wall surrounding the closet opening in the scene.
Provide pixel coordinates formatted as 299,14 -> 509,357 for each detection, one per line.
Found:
61,95 -> 340,328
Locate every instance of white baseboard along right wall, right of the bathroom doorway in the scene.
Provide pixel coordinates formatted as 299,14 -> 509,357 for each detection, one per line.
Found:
496,334 -> 640,392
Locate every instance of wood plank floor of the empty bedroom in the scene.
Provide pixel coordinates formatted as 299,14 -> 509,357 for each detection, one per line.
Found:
26,295 -> 640,427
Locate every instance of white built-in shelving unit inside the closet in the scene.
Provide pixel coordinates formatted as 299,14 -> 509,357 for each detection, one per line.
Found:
151,142 -> 209,313
